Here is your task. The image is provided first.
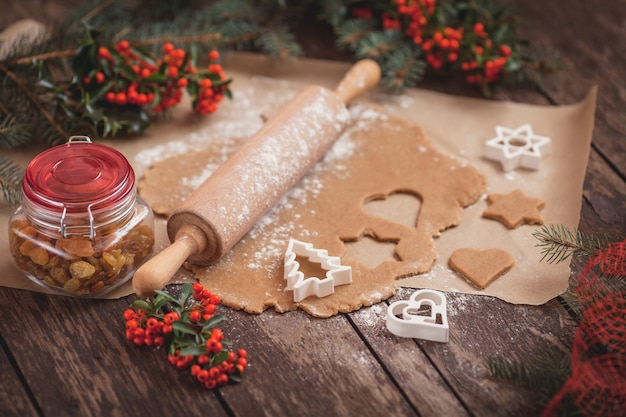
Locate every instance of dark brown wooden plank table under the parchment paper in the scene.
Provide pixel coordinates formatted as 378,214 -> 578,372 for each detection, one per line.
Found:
0,0 -> 626,417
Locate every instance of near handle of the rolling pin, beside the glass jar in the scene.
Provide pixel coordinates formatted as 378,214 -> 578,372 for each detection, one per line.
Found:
133,225 -> 207,297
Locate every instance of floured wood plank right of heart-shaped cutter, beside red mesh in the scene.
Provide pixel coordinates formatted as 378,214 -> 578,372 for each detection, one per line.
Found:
418,294 -> 574,417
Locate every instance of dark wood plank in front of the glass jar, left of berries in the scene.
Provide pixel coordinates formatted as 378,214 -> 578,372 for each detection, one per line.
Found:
0,288 -> 225,417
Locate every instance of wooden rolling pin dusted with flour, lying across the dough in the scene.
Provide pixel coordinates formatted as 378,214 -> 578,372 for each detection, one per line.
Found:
133,60 -> 380,296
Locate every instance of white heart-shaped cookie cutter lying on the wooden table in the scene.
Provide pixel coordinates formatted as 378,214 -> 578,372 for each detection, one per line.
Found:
386,289 -> 449,342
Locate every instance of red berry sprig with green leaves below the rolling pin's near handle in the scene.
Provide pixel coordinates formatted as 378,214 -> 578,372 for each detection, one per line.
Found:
124,283 -> 248,389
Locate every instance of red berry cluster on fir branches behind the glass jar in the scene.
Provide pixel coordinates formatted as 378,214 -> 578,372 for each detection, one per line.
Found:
81,40 -> 230,115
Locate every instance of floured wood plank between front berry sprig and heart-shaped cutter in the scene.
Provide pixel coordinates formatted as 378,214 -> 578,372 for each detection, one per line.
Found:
217,311 -> 417,416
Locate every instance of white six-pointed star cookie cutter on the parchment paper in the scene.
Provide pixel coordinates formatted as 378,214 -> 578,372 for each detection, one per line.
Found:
484,124 -> 552,172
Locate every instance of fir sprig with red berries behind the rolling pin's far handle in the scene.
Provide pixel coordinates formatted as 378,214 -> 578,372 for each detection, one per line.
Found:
319,0 -> 562,96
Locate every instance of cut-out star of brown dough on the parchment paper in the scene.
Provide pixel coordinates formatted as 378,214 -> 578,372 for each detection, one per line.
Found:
483,188 -> 545,229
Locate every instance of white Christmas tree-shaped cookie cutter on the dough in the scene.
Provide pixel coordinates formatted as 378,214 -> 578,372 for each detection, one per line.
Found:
284,239 -> 352,303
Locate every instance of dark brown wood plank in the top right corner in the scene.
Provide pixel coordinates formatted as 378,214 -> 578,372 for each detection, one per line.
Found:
507,0 -> 626,179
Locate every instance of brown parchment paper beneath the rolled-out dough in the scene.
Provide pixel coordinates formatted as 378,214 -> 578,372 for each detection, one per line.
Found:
0,53 -> 596,304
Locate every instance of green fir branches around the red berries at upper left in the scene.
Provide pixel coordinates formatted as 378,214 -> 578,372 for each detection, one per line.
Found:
0,0 -> 301,204
